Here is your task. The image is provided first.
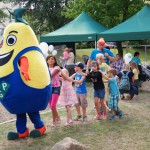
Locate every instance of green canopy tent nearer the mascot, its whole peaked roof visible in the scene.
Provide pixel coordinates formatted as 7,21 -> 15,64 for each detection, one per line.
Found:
40,12 -> 108,43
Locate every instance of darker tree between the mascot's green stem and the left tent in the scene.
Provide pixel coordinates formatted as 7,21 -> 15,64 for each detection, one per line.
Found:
5,0 -> 69,35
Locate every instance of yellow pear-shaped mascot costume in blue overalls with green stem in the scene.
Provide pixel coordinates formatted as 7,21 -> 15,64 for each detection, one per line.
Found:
0,8 -> 52,140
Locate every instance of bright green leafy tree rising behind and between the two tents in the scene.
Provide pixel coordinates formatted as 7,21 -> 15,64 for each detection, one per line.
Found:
62,0 -> 144,55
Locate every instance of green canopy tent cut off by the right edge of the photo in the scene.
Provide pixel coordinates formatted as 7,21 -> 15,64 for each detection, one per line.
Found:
100,5 -> 150,41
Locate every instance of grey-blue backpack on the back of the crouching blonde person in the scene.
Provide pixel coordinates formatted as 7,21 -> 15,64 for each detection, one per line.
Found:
119,71 -> 130,91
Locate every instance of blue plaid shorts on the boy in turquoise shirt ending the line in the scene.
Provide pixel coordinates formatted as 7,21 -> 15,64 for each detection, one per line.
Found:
108,95 -> 120,111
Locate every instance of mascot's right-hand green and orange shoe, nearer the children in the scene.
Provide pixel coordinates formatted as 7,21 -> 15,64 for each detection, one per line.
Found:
30,126 -> 46,138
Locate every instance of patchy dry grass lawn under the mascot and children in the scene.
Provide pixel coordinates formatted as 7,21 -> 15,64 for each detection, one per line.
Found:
0,82 -> 150,150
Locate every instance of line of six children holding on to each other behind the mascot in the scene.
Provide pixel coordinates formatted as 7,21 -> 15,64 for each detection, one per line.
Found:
46,54 -> 122,127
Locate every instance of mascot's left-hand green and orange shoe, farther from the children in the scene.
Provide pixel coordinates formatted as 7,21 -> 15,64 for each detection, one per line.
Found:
7,129 -> 29,140
